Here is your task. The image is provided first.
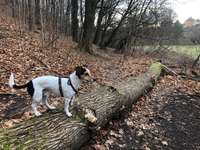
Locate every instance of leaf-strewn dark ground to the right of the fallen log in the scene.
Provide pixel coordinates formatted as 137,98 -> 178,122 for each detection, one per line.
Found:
82,76 -> 200,150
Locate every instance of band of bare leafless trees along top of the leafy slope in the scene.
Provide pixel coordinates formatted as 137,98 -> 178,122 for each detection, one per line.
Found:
1,0 -> 191,53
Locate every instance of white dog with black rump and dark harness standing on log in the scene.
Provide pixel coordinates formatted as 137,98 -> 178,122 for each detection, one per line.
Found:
9,66 -> 92,117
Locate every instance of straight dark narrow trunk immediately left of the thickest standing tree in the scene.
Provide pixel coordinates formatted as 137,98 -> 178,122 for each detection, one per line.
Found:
71,0 -> 78,42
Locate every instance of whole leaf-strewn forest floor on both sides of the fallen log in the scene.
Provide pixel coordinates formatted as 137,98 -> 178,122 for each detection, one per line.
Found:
0,14 -> 200,150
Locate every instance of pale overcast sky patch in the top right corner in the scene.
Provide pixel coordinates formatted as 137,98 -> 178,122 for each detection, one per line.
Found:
172,0 -> 200,23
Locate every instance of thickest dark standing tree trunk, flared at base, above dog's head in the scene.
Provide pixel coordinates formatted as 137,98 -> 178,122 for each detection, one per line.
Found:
79,0 -> 98,54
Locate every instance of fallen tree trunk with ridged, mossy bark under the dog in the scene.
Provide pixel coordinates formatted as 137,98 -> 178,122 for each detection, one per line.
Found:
0,62 -> 164,150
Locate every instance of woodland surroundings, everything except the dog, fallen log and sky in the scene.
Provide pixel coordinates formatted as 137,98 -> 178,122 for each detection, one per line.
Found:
0,0 -> 200,150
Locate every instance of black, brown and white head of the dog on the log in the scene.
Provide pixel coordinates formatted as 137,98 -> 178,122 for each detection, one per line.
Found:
75,66 -> 93,79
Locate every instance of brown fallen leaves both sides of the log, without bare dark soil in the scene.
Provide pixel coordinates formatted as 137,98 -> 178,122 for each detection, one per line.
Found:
0,12 -> 200,150
